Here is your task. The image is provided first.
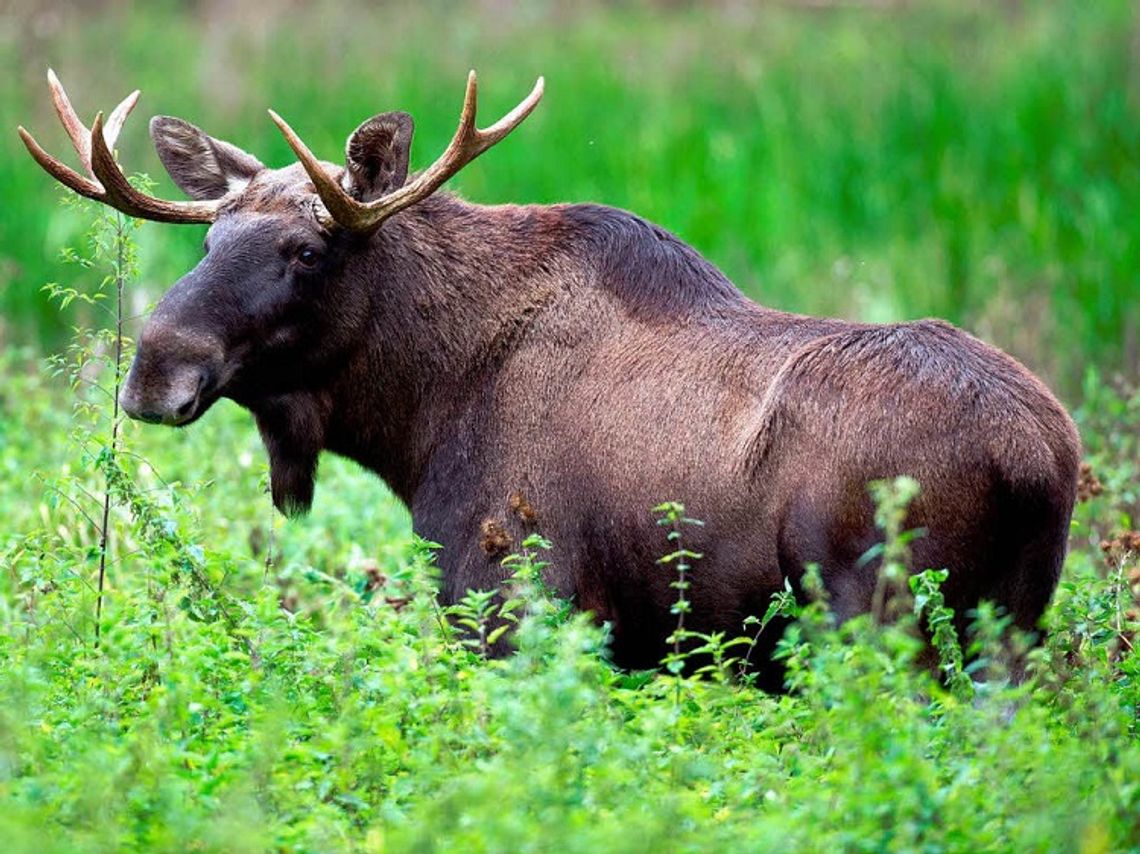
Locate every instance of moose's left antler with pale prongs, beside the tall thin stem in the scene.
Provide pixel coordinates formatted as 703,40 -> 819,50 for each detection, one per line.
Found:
17,68 -> 218,222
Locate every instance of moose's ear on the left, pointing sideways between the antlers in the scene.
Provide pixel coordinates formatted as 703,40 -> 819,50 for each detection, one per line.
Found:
150,115 -> 264,200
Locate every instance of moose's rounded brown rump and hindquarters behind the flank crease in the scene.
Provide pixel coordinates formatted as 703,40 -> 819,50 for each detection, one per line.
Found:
746,320 -> 1080,633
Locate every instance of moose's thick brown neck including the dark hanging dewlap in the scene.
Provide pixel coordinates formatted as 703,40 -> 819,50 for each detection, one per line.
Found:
252,195 -> 562,513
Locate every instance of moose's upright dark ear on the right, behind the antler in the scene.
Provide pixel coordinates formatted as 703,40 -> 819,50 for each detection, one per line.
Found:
341,113 -> 414,202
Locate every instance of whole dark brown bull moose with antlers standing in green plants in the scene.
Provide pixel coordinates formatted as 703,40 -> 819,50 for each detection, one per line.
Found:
19,72 -> 1080,667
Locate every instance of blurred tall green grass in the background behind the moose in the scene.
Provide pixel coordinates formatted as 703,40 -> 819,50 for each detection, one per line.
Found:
0,0 -> 1140,402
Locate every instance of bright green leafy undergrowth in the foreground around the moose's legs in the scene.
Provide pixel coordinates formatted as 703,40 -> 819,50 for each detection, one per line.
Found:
0,337 -> 1140,852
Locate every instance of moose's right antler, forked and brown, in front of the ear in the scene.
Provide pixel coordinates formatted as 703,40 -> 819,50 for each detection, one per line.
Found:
269,71 -> 544,231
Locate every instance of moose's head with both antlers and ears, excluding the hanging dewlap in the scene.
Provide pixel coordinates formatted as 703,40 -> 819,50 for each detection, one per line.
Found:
19,71 -> 543,425
